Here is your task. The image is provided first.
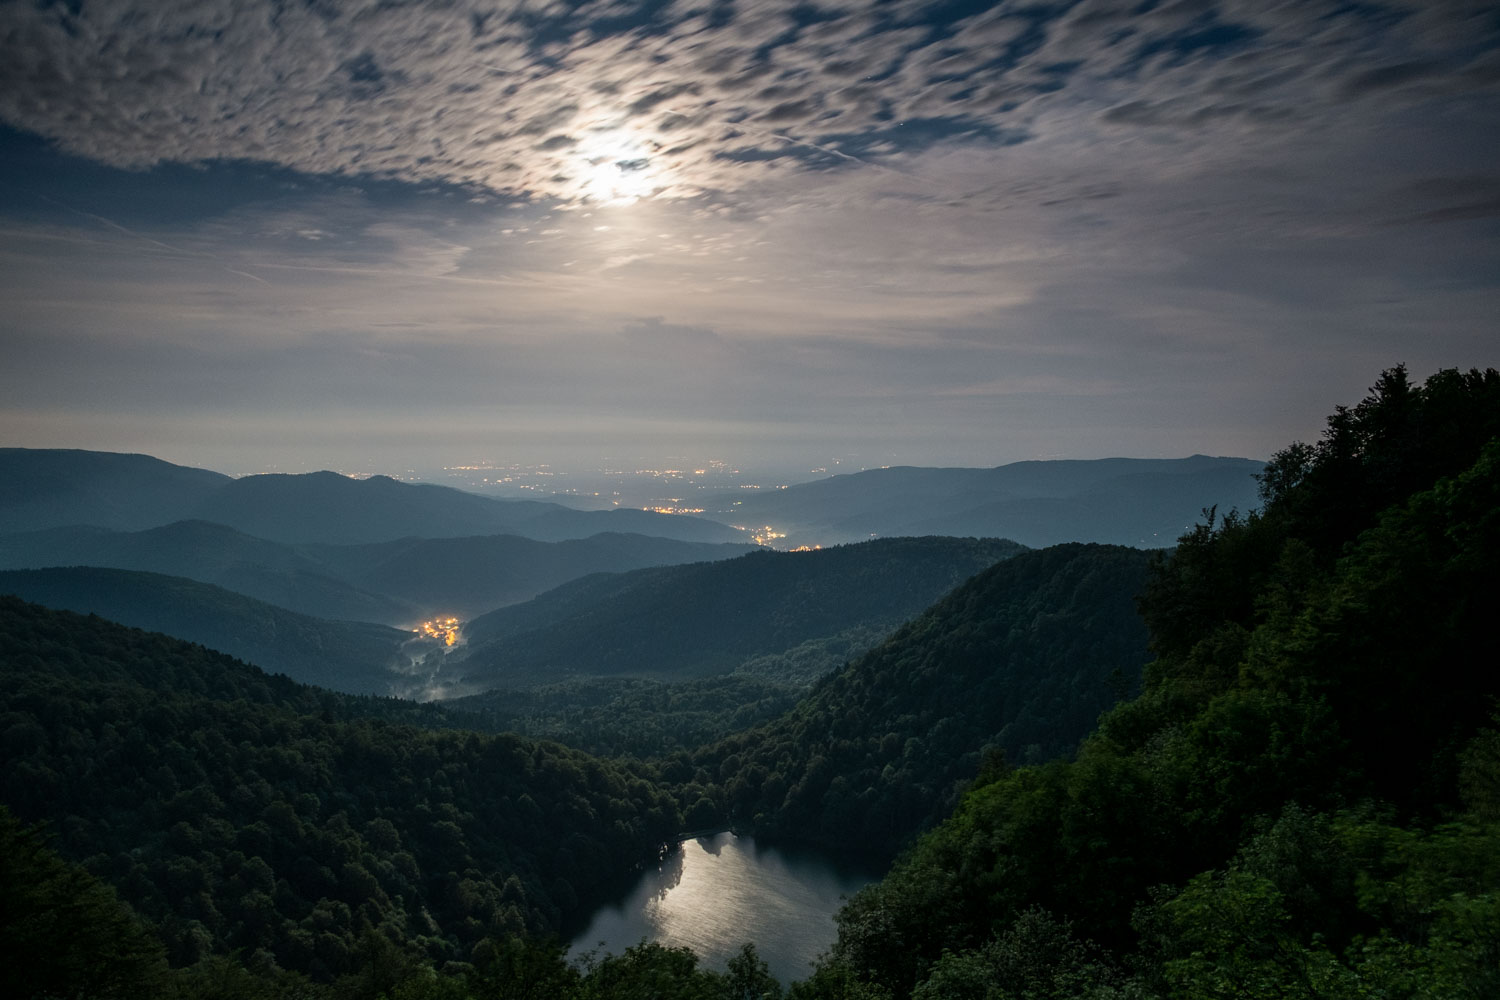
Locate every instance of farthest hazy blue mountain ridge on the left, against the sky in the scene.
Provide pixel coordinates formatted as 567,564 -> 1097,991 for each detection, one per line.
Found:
0,448 -> 746,544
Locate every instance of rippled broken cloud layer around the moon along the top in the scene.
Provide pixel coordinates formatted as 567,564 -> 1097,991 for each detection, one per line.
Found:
0,0 -> 1500,209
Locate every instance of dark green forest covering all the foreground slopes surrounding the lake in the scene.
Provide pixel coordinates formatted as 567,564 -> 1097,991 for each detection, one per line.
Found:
0,367 -> 1500,1000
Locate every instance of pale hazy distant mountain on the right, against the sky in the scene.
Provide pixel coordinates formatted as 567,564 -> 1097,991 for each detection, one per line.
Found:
702,454 -> 1265,549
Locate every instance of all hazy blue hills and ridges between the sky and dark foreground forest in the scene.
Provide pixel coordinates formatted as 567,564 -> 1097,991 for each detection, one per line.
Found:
0,448 -> 1262,671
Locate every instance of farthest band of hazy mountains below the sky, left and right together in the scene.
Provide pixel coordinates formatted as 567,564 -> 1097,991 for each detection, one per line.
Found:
0,448 -> 1263,547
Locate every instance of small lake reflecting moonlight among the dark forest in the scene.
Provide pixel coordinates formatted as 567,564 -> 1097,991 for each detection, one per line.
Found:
570,834 -> 879,984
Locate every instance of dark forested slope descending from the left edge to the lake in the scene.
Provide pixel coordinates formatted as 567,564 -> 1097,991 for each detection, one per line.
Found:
0,598 -> 681,996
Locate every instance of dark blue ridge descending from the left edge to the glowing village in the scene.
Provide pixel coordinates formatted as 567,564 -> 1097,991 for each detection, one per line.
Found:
0,567 -> 423,694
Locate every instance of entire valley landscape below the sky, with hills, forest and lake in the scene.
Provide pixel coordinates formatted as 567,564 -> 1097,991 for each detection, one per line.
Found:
0,369 -> 1500,1000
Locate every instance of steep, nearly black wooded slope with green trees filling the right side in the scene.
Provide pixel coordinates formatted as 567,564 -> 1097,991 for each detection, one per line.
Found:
807,369 -> 1500,999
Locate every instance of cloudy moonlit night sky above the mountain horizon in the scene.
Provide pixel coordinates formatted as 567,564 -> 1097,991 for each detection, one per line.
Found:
0,0 -> 1500,472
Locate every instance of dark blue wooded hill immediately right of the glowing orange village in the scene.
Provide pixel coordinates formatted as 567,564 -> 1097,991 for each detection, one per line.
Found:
455,538 -> 1020,687
